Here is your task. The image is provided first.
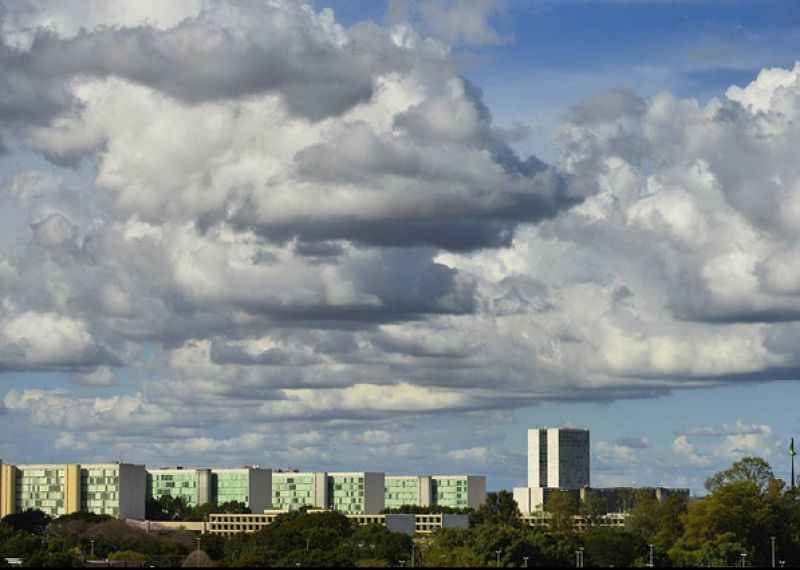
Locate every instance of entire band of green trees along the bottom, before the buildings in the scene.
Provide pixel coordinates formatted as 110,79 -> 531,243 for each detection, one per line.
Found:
0,458 -> 800,567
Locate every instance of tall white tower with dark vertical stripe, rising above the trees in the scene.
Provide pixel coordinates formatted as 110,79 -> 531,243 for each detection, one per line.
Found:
514,428 -> 590,513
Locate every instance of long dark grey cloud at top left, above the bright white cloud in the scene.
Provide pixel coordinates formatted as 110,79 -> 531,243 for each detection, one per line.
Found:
0,2 -> 400,122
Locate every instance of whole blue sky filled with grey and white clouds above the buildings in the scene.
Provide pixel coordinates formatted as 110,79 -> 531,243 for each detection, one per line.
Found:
0,0 -> 800,494
